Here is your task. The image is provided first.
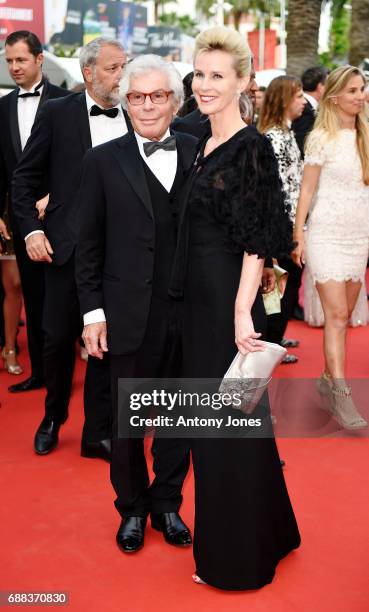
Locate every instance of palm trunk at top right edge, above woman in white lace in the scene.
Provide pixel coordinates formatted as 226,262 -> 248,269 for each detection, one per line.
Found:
349,0 -> 369,66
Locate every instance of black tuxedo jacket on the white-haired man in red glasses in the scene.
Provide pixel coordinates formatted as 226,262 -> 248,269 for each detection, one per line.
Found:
76,132 -> 197,355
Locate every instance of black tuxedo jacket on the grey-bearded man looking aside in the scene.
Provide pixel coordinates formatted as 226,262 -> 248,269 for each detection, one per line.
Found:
13,92 -> 130,265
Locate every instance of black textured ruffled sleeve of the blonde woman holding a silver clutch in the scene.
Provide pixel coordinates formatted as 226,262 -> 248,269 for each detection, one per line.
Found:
207,130 -> 293,257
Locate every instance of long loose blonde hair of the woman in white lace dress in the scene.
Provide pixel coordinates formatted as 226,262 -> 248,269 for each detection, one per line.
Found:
306,65 -> 369,185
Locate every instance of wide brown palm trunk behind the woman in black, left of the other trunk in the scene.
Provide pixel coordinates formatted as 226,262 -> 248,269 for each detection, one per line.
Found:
287,0 -> 322,76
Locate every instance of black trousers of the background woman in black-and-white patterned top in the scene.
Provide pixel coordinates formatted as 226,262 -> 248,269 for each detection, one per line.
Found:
267,257 -> 302,344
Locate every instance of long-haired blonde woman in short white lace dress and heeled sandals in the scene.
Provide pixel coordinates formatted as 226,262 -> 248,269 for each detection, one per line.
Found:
293,66 -> 369,429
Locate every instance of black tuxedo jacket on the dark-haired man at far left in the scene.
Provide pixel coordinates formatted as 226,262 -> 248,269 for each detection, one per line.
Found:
0,80 -> 70,222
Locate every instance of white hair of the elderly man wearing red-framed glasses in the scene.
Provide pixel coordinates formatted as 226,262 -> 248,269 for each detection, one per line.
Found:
119,54 -> 184,108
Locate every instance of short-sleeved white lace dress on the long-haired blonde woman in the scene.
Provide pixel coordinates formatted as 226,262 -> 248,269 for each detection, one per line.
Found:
305,129 -> 369,283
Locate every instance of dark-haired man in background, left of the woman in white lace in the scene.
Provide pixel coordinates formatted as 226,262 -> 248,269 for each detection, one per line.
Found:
291,66 -> 328,158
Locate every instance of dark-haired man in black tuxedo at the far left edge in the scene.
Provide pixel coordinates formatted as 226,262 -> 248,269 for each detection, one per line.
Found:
0,30 -> 69,393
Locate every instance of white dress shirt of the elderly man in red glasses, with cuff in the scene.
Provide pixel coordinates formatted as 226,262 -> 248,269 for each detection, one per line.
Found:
83,129 -> 177,325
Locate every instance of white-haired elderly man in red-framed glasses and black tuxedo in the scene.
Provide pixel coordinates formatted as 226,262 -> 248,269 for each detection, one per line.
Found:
77,55 -> 197,552
